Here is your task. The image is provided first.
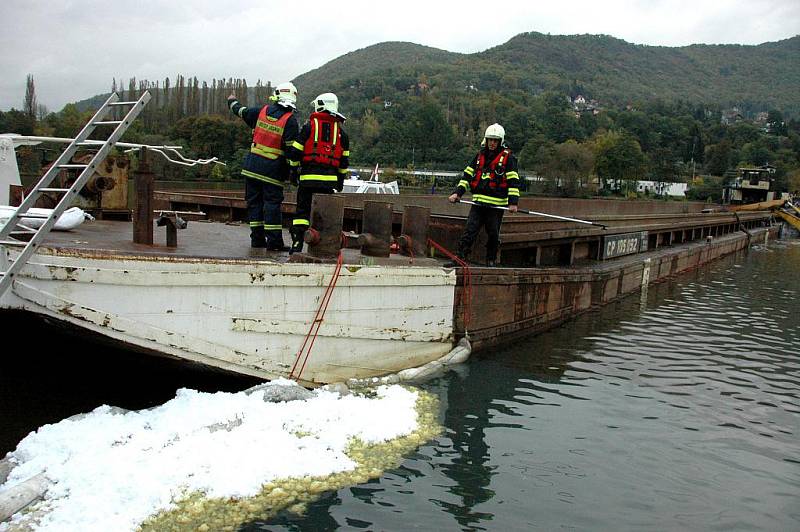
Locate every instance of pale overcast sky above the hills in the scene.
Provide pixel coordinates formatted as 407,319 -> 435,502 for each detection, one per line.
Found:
0,0 -> 800,111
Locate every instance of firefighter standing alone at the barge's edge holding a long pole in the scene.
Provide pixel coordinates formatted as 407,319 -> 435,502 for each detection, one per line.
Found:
447,124 -> 519,267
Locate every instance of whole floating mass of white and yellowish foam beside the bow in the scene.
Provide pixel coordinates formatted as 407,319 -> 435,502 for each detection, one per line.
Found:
0,380 -> 441,532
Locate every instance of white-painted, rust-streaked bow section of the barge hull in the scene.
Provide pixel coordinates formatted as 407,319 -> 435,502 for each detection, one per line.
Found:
0,252 -> 456,384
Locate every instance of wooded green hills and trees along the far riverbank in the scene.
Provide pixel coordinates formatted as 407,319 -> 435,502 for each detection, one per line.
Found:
0,34 -> 800,200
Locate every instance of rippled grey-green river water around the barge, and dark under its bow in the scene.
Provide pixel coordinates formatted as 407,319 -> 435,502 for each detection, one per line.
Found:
0,240 -> 800,530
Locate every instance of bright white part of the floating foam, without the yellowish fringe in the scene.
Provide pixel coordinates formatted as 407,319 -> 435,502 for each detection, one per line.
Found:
0,381 -> 417,532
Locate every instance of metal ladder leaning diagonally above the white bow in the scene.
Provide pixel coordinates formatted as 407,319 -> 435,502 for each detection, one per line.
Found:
0,91 -> 150,298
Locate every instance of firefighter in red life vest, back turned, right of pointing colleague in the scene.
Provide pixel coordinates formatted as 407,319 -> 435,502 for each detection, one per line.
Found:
290,92 -> 350,253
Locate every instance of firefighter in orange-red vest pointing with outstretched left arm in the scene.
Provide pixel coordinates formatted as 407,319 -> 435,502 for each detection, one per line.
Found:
228,82 -> 300,251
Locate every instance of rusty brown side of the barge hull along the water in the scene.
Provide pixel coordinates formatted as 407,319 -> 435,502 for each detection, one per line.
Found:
454,227 -> 779,351
